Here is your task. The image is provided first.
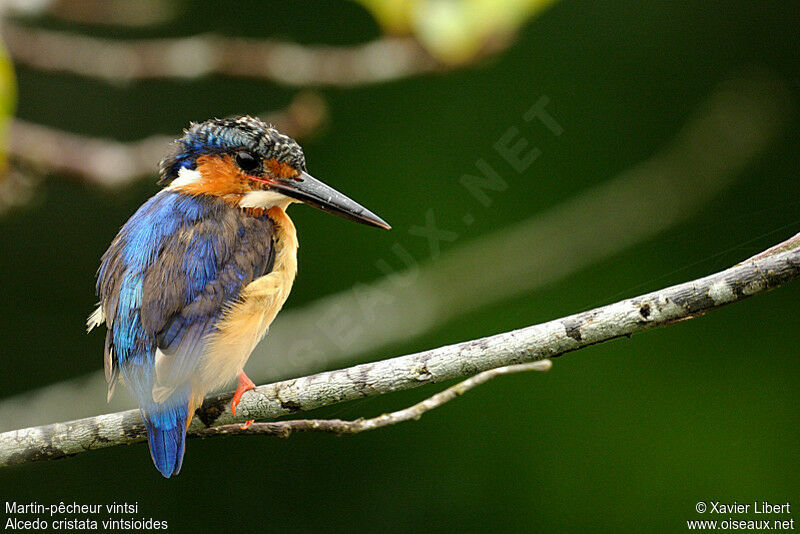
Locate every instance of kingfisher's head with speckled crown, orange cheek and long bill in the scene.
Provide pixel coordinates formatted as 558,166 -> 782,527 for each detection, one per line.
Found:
159,117 -> 390,230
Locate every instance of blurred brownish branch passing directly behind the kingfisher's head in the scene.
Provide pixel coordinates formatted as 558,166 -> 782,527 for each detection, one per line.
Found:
9,92 -> 327,186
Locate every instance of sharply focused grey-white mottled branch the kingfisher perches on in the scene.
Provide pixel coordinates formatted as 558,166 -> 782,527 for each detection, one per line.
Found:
0,233 -> 800,466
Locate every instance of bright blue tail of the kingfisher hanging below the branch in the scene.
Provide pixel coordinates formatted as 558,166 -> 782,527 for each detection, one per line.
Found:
142,405 -> 188,478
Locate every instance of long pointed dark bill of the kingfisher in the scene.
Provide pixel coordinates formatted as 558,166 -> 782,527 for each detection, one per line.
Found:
273,172 -> 392,230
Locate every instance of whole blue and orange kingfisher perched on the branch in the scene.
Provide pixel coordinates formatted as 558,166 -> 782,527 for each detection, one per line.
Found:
87,116 -> 390,478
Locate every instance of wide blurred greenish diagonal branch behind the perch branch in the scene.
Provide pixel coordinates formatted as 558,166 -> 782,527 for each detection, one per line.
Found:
0,73 -> 793,430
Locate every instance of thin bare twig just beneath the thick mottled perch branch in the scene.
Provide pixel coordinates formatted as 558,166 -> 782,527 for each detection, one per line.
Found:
195,360 -> 553,438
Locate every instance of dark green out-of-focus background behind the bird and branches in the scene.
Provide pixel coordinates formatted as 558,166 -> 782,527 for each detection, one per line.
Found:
0,0 -> 800,532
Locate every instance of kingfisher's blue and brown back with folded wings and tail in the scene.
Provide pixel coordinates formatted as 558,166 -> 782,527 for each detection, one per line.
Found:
97,191 -> 274,476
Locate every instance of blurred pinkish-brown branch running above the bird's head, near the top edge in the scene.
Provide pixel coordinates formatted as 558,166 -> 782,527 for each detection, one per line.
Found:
3,21 -> 445,87
